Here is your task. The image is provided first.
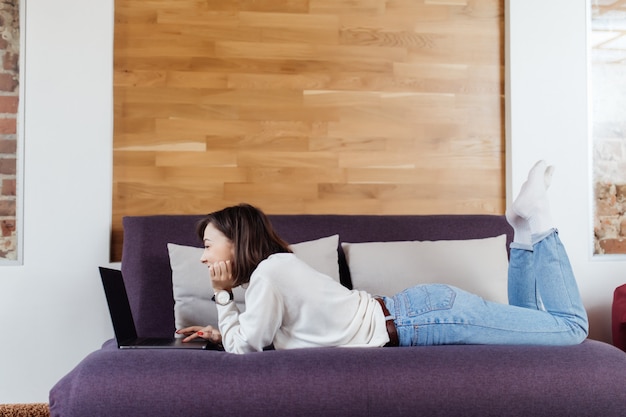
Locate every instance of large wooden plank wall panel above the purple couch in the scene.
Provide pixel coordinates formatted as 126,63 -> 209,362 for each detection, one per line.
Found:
112,0 -> 505,259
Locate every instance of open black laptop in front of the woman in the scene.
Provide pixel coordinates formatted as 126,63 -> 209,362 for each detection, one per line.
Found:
100,267 -> 223,350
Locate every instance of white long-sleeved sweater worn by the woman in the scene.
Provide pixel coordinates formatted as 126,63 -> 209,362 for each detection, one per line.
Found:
217,253 -> 389,353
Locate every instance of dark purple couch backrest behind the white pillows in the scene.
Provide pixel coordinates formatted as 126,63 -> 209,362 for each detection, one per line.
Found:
122,215 -> 512,337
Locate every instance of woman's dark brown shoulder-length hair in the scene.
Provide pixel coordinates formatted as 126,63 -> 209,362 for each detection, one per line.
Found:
196,204 -> 291,286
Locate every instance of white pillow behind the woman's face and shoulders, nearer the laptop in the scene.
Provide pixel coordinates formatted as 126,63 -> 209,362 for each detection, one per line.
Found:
167,235 -> 339,329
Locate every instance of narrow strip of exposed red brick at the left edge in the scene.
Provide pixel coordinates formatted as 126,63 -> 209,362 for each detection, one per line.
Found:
0,0 -> 20,260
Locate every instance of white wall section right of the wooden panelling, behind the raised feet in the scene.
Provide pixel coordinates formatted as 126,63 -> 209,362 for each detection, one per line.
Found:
507,0 -> 626,342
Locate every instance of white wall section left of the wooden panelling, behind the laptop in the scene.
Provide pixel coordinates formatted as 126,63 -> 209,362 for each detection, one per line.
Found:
0,0 -> 113,403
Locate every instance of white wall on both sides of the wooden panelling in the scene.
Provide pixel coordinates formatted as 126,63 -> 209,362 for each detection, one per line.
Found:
0,0 -> 626,403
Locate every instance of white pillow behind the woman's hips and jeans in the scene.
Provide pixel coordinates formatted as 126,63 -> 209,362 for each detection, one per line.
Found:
341,235 -> 508,304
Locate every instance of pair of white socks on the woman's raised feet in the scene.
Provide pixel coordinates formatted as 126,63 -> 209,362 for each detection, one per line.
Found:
511,161 -> 554,235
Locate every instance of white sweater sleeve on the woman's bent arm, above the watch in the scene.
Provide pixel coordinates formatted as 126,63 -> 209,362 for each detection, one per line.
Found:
217,279 -> 283,353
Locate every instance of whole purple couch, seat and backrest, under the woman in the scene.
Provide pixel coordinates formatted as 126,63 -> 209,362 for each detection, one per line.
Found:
50,215 -> 626,417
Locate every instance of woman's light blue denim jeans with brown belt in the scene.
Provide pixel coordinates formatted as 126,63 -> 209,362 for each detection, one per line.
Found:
384,230 -> 588,346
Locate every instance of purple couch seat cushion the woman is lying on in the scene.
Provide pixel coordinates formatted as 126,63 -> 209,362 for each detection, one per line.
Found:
50,340 -> 626,417
